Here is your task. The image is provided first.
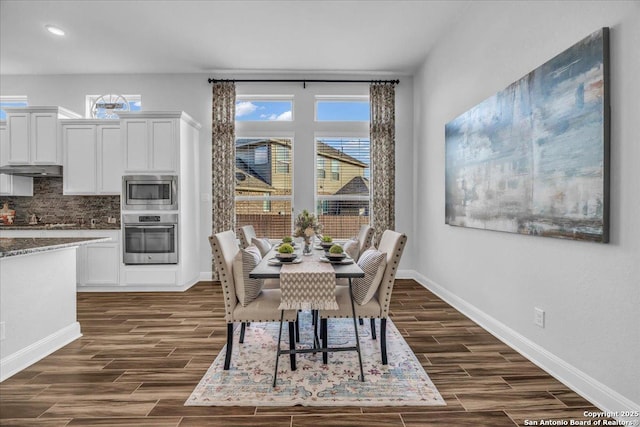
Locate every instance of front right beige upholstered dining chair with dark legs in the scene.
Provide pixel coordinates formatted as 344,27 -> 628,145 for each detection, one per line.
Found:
320,230 -> 407,365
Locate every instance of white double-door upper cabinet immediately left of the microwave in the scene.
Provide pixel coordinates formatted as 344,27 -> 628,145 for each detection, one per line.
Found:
61,120 -> 122,195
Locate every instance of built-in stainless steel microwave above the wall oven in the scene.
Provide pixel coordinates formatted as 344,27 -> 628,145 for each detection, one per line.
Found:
122,175 -> 178,210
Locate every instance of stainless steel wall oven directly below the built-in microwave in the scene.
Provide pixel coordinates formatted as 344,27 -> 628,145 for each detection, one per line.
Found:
122,213 -> 178,264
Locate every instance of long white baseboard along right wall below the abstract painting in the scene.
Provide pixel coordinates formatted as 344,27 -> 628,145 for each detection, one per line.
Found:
408,270 -> 640,425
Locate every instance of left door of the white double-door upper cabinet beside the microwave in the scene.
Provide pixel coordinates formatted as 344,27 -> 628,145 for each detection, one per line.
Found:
62,125 -> 97,194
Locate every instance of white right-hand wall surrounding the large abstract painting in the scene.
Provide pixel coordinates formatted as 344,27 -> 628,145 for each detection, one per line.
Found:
413,1 -> 640,409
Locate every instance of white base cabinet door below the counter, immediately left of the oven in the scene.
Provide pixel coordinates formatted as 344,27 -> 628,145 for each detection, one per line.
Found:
83,243 -> 120,285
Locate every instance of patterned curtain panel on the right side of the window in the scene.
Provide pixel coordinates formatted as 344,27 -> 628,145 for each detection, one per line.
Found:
369,83 -> 395,246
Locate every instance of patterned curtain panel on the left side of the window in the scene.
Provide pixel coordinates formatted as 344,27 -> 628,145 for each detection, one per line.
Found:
211,82 -> 236,280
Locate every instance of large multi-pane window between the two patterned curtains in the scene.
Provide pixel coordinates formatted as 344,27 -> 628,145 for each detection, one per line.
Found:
235,89 -> 370,239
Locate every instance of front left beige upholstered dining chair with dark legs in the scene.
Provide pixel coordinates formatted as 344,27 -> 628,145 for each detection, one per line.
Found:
209,231 -> 297,371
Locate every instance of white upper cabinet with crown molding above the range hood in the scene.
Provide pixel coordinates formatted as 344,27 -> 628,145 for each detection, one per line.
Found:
0,107 -> 80,165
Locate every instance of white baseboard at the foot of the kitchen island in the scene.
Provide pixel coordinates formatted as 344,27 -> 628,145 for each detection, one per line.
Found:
0,322 -> 82,382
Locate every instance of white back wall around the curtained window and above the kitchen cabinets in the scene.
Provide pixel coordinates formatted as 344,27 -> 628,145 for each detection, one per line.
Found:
0,74 -> 413,277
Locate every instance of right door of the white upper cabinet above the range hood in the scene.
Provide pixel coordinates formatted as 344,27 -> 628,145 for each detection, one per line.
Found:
30,113 -> 61,165
